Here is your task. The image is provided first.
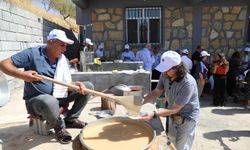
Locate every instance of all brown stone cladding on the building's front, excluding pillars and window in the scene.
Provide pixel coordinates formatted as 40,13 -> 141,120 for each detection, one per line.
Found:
91,6 -> 247,60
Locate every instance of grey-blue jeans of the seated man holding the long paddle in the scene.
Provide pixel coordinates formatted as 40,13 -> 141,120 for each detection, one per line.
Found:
26,82 -> 94,128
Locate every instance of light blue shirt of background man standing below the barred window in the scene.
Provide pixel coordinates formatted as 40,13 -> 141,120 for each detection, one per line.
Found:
136,48 -> 155,71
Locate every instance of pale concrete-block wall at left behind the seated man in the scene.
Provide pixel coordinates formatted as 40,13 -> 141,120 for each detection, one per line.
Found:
0,1 -> 65,89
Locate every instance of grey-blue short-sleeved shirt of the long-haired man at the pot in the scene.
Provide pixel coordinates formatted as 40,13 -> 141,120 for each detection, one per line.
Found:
157,73 -> 200,122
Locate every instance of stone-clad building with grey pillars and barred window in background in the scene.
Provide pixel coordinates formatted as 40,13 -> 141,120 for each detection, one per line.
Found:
72,0 -> 250,59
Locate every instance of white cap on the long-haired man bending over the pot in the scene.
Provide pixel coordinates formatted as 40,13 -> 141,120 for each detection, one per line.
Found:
155,51 -> 181,72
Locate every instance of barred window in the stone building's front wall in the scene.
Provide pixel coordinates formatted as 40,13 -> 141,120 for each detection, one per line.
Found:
125,7 -> 161,44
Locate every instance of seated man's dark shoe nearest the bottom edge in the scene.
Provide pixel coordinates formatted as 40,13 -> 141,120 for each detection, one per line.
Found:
55,128 -> 72,144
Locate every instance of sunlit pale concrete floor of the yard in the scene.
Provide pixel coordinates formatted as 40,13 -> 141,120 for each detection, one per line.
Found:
0,88 -> 250,150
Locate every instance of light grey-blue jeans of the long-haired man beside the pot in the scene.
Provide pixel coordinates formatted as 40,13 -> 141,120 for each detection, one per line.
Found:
169,119 -> 196,150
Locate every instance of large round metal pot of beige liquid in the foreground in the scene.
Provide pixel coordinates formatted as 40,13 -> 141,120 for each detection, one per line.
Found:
79,116 -> 156,150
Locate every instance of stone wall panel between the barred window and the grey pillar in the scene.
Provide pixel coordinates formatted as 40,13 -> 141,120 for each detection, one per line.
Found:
163,7 -> 193,50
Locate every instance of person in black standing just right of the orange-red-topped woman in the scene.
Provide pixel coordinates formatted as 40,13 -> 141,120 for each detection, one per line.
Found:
227,51 -> 241,101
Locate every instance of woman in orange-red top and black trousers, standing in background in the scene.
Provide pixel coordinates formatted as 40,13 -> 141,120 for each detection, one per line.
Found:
213,53 -> 229,106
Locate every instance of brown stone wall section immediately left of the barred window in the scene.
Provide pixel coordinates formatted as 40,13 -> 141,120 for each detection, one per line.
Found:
91,8 -> 125,60
